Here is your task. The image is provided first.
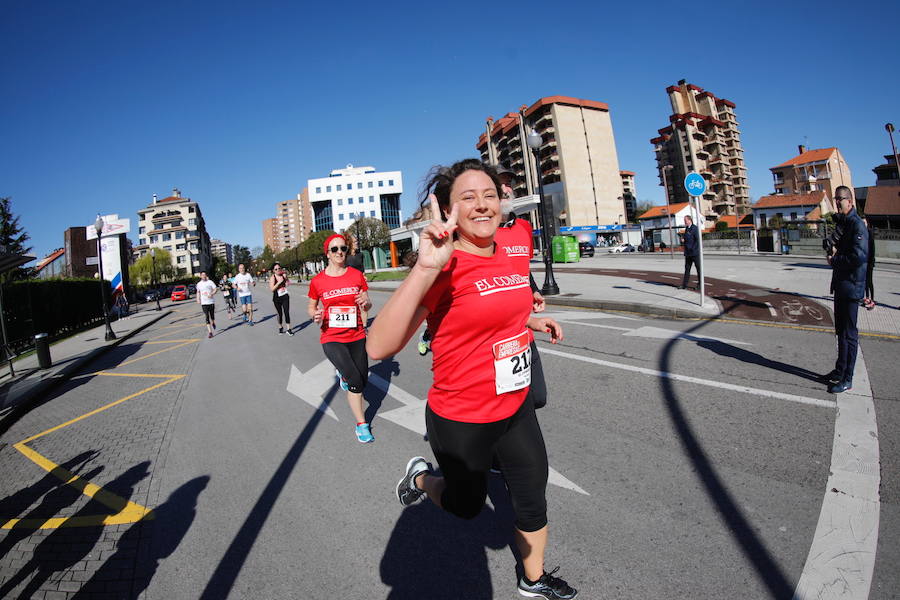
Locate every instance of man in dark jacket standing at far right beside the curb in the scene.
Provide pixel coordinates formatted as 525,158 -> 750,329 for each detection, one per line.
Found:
826,185 -> 869,394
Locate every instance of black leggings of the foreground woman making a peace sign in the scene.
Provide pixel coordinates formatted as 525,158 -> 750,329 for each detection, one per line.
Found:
425,398 -> 547,532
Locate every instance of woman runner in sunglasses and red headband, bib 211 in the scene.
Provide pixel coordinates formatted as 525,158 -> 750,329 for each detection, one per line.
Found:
307,233 -> 375,444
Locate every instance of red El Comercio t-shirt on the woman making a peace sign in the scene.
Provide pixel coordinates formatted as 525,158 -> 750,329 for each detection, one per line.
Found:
422,247 -> 532,423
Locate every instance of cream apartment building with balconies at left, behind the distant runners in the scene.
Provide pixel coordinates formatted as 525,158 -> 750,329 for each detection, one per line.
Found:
133,188 -> 212,275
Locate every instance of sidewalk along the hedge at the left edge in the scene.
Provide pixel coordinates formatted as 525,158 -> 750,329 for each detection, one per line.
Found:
0,304 -> 172,433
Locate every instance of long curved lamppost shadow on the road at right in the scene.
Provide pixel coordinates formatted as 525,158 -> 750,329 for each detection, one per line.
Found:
658,309 -> 794,600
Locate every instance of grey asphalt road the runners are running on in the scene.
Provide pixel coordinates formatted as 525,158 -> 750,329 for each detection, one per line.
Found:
0,289 -> 900,599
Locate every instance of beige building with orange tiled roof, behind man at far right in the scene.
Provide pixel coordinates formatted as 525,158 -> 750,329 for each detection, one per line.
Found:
769,146 -> 853,201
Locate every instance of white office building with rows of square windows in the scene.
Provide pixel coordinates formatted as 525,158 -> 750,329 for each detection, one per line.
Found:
308,165 -> 403,233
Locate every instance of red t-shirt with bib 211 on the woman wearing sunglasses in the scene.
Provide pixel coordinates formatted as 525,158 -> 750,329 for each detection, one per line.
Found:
309,268 -> 369,344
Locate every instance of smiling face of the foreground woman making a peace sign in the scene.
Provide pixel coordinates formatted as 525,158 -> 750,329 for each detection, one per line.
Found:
450,170 -> 501,246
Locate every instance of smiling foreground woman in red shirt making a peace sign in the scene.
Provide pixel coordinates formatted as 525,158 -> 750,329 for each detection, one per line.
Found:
366,159 -> 578,599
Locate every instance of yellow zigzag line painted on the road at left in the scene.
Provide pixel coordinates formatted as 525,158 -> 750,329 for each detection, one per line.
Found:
0,371 -> 185,529
